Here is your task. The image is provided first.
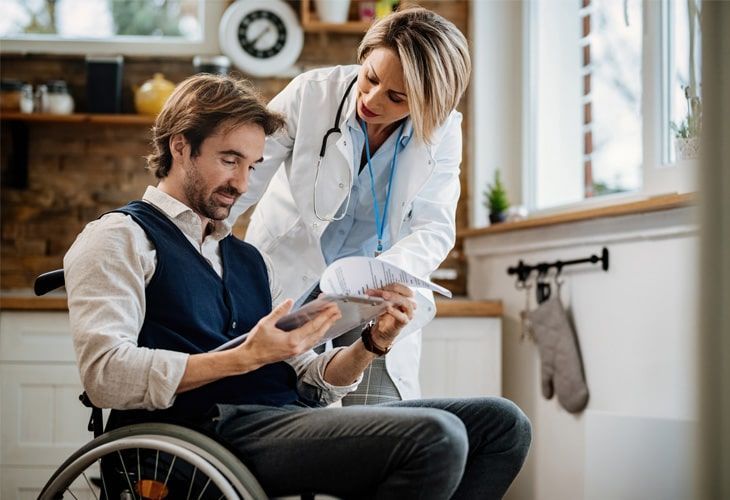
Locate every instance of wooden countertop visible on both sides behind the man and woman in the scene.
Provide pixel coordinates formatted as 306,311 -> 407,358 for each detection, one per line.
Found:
0,292 -> 502,318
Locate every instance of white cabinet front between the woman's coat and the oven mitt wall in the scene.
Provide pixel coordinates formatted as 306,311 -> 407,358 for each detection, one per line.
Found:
420,318 -> 502,398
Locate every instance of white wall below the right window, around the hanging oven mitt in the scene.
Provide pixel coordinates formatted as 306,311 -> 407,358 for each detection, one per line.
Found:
465,208 -> 698,500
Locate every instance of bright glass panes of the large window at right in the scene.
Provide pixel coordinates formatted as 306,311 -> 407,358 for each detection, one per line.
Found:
523,0 -> 701,210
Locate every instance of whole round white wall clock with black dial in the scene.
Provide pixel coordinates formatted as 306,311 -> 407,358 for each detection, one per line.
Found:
218,0 -> 304,76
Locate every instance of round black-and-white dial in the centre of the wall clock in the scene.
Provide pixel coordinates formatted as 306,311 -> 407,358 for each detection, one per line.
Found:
238,9 -> 287,59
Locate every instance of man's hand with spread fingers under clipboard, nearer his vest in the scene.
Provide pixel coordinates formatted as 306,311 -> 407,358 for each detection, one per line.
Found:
233,299 -> 340,368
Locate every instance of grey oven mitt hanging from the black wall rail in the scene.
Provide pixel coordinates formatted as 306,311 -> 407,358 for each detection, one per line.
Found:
525,294 -> 588,413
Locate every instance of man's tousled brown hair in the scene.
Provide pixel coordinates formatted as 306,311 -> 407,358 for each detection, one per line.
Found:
147,75 -> 286,179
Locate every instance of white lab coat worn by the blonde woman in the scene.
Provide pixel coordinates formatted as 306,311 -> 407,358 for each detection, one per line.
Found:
231,65 -> 461,399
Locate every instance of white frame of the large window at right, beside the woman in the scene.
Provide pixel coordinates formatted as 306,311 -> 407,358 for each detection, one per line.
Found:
471,0 -> 698,225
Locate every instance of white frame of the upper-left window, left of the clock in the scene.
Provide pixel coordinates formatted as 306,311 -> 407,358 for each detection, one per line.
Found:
0,0 -> 226,56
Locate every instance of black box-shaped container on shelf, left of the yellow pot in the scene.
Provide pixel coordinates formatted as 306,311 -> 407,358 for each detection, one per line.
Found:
86,56 -> 124,113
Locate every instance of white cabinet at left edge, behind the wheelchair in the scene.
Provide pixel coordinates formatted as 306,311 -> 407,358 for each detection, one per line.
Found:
0,311 -> 93,500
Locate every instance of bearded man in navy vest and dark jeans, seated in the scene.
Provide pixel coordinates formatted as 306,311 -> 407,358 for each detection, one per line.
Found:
64,75 -> 531,499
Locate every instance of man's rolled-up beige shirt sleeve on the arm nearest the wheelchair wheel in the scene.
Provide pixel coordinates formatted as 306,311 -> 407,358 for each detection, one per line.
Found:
63,213 -> 188,410
